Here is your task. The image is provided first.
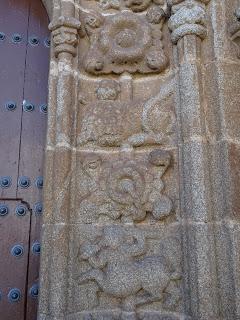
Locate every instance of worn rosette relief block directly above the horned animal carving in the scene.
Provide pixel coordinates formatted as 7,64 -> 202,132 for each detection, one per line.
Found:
72,148 -> 178,224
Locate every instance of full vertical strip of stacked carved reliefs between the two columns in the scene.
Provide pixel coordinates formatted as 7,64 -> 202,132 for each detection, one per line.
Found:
69,0 -> 183,320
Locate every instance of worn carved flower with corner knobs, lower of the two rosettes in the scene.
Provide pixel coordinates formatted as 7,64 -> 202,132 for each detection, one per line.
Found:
78,149 -> 173,223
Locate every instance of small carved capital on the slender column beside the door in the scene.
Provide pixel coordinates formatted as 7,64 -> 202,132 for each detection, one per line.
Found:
49,16 -> 81,57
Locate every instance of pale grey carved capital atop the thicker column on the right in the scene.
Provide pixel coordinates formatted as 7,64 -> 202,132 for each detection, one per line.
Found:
169,0 -> 209,44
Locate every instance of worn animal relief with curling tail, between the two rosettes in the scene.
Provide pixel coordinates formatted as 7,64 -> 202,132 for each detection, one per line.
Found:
77,79 -> 175,147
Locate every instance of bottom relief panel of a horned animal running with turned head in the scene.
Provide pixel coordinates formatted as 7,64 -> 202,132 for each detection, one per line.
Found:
68,224 -> 184,320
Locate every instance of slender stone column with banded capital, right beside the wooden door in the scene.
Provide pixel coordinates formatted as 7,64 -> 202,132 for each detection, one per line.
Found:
39,0 -> 80,320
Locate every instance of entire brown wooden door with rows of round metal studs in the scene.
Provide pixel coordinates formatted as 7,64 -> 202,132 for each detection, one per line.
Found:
0,0 -> 50,320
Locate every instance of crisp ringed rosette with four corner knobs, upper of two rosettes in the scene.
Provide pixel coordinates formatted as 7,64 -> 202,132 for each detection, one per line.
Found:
80,12 -> 168,74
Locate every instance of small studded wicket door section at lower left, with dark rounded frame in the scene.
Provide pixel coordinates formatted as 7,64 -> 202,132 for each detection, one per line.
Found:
0,200 -> 31,320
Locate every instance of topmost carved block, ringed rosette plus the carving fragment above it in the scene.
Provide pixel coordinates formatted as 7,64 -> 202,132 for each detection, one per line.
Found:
80,0 -> 169,75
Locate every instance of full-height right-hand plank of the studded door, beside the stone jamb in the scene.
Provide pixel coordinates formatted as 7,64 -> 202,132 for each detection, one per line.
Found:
20,0 -> 49,320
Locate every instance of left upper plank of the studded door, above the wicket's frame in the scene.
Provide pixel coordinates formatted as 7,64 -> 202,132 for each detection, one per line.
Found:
0,0 -> 29,198
